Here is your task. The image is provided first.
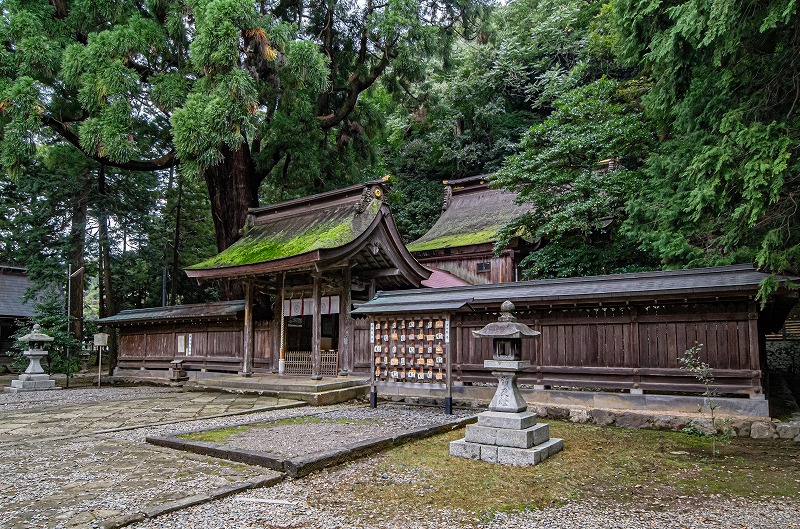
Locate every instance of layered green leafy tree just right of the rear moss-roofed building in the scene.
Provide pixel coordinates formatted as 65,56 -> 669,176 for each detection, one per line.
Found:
495,78 -> 657,277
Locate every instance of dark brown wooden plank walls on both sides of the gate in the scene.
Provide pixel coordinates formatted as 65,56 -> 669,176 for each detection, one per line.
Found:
119,301 -> 764,395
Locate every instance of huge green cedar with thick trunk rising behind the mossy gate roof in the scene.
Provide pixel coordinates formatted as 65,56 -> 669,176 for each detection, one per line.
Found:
0,0 -> 483,262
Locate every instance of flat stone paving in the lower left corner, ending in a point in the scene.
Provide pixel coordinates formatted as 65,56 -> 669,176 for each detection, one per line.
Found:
0,436 -> 280,529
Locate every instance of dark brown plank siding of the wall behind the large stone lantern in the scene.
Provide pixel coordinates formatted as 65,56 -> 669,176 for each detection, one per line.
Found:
444,303 -> 761,394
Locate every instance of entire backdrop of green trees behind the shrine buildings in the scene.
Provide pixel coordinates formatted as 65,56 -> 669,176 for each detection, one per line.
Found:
0,0 -> 800,334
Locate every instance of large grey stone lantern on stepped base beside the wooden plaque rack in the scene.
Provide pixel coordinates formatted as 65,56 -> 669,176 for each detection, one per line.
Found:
450,301 -> 564,466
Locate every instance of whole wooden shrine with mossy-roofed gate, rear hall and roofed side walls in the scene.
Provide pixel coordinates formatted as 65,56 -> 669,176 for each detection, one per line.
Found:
98,176 -> 797,415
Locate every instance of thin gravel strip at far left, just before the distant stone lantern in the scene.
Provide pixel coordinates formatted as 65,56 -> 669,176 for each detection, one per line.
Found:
0,386 -> 183,412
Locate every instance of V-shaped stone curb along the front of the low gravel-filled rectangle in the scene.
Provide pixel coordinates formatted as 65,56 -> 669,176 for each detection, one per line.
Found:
145,415 -> 477,478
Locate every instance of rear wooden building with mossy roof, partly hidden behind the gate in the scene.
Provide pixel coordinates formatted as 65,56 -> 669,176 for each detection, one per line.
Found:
408,175 -> 534,284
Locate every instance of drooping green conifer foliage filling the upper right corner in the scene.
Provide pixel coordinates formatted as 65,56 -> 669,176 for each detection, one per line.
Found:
617,0 -> 800,288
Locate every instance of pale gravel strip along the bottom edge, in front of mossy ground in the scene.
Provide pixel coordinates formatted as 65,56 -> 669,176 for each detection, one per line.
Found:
131,455 -> 800,529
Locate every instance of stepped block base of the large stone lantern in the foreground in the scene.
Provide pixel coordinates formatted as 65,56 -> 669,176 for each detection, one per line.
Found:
450,411 -> 564,466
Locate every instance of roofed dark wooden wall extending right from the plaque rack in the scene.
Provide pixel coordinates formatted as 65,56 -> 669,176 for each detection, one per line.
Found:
354,265 -> 797,397
